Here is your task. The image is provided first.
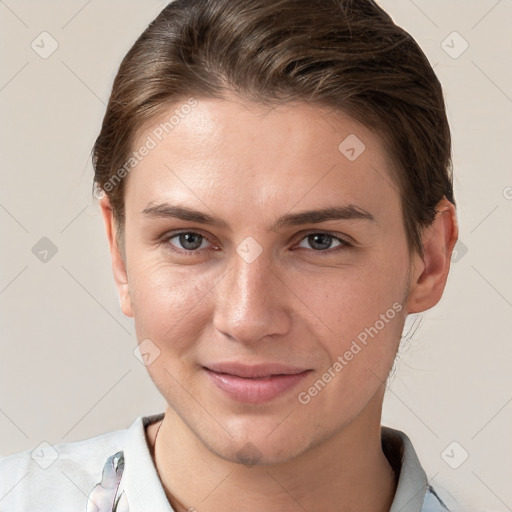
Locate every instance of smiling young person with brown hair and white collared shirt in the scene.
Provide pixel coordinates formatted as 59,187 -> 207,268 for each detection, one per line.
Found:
0,0 -> 458,512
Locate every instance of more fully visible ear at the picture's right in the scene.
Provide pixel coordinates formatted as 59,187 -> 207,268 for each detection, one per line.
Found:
406,197 -> 459,313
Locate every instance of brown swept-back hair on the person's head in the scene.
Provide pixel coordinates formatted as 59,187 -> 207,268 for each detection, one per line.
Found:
93,0 -> 455,255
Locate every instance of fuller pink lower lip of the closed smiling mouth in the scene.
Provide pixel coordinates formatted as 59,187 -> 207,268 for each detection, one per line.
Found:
205,368 -> 310,404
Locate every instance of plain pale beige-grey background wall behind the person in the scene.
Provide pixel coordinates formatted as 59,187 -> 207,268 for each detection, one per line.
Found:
0,0 -> 512,512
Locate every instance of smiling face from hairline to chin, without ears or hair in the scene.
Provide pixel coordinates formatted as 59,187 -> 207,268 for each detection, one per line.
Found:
102,96 -> 430,462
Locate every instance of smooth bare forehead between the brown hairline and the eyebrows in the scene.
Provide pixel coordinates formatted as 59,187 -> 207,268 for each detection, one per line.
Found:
126,99 -> 399,222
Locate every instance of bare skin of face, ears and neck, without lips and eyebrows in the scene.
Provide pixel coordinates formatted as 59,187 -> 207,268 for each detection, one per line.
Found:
100,98 -> 458,512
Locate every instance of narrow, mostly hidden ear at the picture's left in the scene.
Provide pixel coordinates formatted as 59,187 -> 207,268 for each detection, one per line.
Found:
99,195 -> 133,317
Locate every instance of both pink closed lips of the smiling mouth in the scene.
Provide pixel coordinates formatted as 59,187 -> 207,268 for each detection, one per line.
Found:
203,363 -> 311,404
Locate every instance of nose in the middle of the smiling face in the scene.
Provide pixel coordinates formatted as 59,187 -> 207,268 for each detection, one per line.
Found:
214,244 -> 292,344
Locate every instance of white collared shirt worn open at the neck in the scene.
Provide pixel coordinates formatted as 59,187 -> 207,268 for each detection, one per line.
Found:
0,413 -> 454,512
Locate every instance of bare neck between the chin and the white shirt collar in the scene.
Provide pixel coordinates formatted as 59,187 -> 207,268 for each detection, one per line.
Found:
150,392 -> 396,512
